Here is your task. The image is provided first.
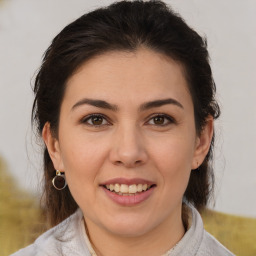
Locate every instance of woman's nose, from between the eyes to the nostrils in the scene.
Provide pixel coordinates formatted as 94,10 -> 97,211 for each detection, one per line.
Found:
109,127 -> 148,168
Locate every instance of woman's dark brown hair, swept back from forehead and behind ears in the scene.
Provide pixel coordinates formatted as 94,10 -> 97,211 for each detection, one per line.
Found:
32,1 -> 220,225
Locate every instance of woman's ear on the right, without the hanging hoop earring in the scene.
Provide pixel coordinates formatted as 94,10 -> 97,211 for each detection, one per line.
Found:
191,116 -> 214,170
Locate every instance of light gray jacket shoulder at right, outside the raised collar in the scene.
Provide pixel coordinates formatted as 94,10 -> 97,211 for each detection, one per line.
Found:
197,230 -> 234,256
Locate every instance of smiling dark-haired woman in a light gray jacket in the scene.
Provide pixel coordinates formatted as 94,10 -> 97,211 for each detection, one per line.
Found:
14,1 -> 232,256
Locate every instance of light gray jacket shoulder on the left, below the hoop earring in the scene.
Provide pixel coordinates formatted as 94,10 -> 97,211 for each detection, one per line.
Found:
11,210 -> 90,256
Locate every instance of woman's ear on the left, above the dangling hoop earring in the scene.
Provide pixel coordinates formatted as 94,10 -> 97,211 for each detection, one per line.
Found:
42,122 -> 64,172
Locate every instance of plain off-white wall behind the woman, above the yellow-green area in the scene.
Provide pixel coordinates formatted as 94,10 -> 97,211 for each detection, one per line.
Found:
0,0 -> 256,217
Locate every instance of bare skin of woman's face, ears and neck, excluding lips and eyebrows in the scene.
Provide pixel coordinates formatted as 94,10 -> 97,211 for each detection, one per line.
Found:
43,48 -> 213,256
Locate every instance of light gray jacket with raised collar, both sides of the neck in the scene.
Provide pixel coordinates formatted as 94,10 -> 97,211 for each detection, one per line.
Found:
11,205 -> 234,256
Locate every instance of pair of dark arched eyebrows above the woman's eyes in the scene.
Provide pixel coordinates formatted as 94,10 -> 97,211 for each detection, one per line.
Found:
72,98 -> 184,112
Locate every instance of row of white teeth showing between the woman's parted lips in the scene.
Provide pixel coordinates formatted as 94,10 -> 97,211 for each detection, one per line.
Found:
103,184 -> 156,196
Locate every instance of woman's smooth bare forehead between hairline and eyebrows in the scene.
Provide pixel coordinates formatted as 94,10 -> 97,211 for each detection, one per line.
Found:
64,48 -> 191,109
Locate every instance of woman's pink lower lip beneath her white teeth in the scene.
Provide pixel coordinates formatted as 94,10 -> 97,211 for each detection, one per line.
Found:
102,186 -> 155,206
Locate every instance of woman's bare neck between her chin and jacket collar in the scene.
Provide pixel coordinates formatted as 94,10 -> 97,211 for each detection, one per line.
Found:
86,207 -> 185,256
